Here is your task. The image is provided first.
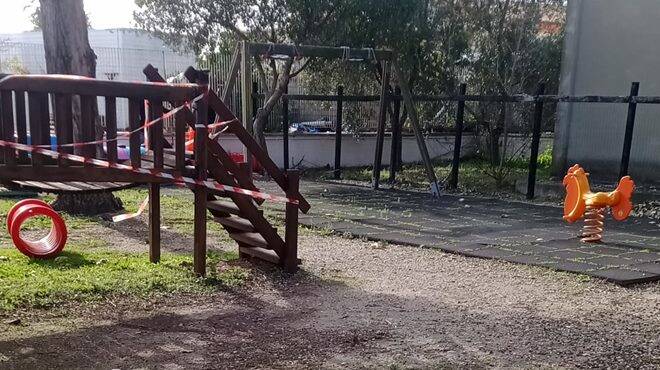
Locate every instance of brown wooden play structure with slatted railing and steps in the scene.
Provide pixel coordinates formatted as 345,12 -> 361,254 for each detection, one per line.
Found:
0,66 -> 310,275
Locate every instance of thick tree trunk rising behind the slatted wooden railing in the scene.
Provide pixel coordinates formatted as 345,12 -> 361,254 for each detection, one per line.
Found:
39,0 -> 122,215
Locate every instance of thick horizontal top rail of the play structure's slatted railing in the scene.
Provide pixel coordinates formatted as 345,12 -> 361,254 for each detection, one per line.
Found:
0,75 -> 204,101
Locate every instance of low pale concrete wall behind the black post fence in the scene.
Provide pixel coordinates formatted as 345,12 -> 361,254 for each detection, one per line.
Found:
219,134 -> 552,168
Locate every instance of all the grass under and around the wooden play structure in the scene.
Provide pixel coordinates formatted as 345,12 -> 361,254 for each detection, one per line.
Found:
0,188 -> 249,313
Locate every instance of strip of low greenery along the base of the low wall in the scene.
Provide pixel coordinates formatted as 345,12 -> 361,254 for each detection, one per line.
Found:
305,153 -> 551,193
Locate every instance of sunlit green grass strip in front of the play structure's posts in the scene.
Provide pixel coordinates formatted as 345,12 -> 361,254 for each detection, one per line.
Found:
0,247 -> 249,311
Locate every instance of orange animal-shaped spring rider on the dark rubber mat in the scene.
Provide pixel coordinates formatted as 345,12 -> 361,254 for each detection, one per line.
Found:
563,164 -> 635,243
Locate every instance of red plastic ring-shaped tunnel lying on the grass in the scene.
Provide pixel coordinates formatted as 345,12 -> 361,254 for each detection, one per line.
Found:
7,199 -> 68,259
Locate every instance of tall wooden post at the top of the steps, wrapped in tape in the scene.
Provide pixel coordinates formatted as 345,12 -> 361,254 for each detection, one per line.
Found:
193,77 -> 209,276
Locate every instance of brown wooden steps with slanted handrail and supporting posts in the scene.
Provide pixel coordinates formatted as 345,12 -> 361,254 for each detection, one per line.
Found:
144,65 -> 310,274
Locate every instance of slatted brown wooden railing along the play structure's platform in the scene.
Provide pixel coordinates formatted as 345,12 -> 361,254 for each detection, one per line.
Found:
0,75 -> 204,182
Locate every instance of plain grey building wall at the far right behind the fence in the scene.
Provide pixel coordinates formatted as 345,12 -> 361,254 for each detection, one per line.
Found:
554,0 -> 660,181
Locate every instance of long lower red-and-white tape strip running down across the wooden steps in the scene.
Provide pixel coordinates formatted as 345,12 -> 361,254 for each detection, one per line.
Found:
0,140 -> 298,204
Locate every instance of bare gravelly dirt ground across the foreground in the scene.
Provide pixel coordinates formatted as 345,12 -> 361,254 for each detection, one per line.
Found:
0,225 -> 660,369
